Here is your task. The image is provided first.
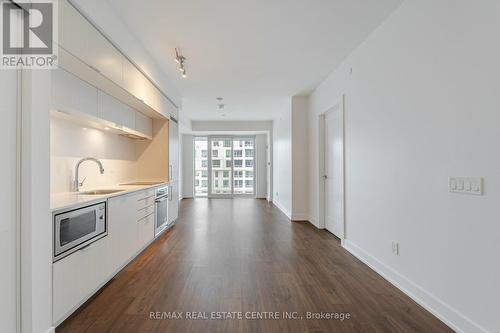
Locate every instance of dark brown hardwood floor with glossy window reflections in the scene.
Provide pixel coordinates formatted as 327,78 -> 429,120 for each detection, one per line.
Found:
57,199 -> 452,333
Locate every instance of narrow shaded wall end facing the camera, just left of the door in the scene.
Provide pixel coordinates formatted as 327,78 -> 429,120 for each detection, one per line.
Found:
291,96 -> 309,221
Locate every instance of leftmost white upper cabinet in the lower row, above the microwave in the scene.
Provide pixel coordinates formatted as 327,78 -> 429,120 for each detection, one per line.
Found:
52,68 -> 98,117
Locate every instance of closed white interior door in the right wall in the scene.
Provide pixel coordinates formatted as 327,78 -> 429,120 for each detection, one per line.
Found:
324,104 -> 344,238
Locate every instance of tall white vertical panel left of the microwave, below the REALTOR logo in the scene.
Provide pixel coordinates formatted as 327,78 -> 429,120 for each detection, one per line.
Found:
21,70 -> 53,333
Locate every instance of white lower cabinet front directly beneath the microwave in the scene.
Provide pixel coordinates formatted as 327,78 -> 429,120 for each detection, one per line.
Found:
53,237 -> 112,323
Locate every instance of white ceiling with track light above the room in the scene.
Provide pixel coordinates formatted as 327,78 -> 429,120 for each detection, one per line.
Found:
107,0 -> 402,120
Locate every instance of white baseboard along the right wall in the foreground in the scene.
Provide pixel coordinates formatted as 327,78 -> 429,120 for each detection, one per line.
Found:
343,239 -> 488,333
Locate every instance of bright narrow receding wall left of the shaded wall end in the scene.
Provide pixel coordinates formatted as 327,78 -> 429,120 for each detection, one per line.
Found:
273,100 -> 292,218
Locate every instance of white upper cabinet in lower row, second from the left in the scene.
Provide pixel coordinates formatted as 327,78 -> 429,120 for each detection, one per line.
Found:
99,91 -> 135,129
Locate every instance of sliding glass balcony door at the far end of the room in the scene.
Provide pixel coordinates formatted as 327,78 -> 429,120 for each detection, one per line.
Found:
194,136 -> 255,197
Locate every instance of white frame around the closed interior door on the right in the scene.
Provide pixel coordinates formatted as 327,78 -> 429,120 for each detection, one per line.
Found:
318,94 -> 346,245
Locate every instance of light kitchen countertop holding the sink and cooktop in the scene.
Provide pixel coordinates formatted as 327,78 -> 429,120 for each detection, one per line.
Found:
50,182 -> 168,212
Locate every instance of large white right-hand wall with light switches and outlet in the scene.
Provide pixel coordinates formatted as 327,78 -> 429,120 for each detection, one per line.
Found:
308,0 -> 500,332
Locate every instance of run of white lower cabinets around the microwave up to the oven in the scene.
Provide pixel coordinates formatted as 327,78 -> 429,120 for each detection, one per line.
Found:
52,189 -> 159,325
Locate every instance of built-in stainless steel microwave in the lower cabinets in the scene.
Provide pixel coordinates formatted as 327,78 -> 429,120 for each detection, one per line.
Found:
53,202 -> 108,262
